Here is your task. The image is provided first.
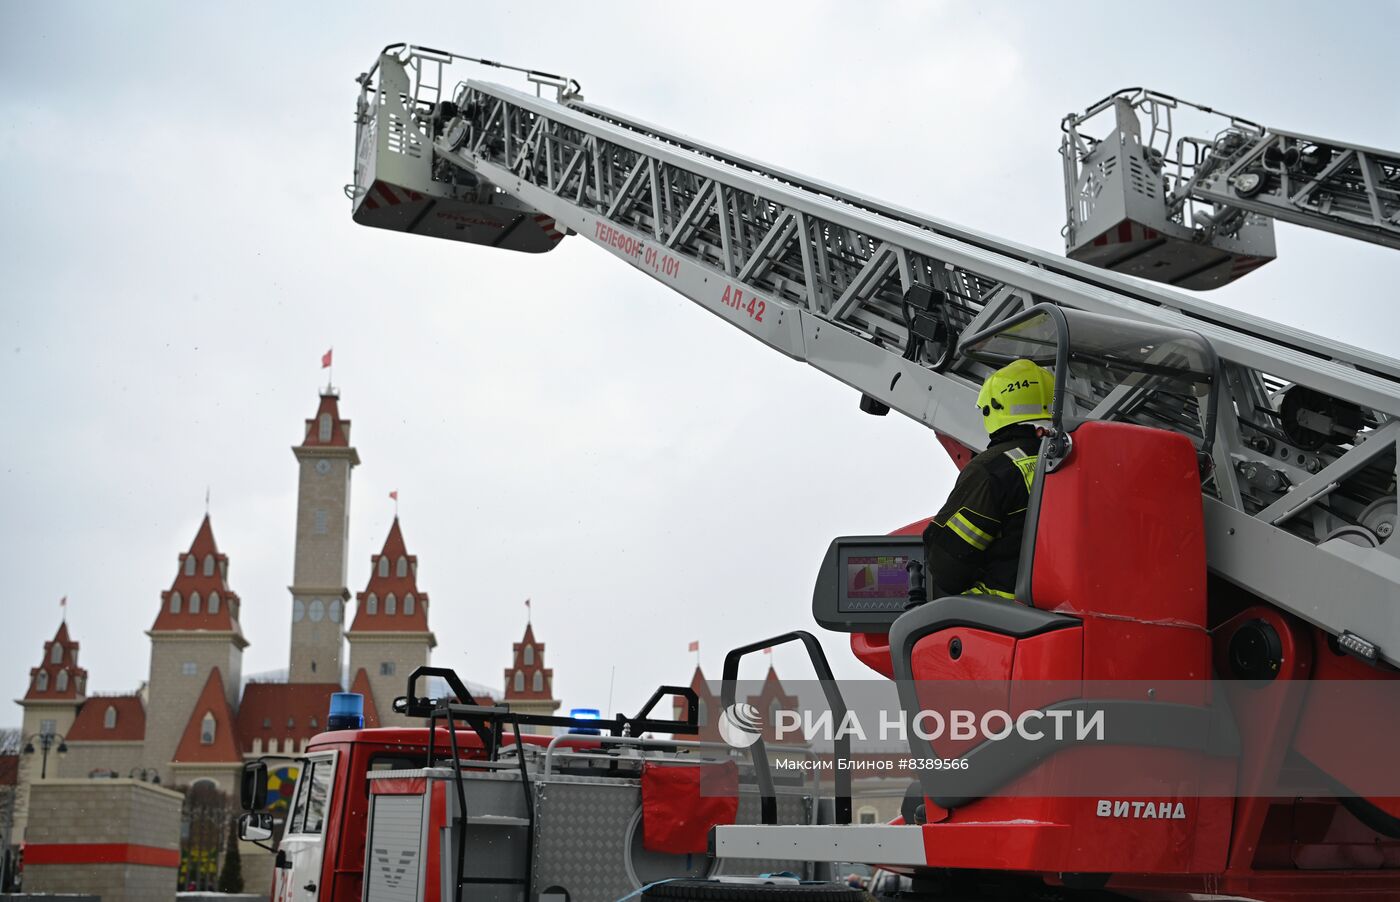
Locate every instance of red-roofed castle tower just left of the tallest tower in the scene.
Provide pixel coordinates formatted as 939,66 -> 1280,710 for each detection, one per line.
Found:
143,514 -> 248,784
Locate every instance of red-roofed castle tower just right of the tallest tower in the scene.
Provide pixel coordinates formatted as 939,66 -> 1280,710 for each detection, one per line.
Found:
346,517 -> 437,727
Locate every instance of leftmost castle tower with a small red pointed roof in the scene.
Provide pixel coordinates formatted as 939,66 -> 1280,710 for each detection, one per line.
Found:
13,622 -> 87,842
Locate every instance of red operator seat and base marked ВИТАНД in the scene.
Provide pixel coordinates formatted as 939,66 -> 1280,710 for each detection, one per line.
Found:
889,422 -> 1239,874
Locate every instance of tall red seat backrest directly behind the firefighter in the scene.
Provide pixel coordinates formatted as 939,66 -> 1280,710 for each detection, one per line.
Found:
1016,420 -> 1205,627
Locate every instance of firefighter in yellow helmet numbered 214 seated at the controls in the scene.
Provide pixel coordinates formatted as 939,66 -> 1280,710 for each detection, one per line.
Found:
924,360 -> 1054,601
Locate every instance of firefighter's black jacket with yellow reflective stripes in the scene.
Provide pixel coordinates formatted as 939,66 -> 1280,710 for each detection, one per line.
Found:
924,423 -> 1040,599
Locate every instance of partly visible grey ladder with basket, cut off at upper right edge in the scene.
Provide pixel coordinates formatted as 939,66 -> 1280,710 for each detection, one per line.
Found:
1060,88 -> 1400,289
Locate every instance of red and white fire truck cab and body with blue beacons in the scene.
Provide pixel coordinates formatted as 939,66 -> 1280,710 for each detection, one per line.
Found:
239,666 -> 858,902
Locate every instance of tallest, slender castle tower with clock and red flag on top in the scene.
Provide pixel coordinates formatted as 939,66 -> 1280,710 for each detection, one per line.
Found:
285,388 -> 360,685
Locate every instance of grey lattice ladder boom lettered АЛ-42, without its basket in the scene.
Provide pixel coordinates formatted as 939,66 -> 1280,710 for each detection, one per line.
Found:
356,52 -> 1400,662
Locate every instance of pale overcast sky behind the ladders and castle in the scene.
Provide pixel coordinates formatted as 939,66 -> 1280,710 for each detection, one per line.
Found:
0,0 -> 1400,724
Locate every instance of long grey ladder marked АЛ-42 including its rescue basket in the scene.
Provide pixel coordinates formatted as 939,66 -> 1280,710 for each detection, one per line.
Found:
347,46 -> 1400,664
